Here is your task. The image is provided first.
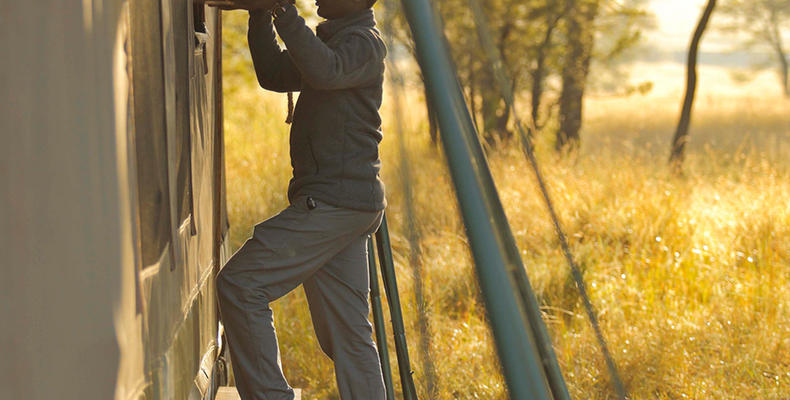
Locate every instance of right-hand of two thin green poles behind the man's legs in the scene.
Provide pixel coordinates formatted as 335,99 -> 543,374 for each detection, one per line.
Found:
376,214 -> 417,400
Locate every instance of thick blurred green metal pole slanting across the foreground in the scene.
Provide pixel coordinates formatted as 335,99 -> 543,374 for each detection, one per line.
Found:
402,0 -> 568,400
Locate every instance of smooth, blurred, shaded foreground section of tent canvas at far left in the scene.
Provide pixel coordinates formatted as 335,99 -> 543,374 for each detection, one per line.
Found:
0,0 -> 129,399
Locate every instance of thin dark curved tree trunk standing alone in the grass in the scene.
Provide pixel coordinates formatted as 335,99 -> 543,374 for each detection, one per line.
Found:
669,0 -> 716,174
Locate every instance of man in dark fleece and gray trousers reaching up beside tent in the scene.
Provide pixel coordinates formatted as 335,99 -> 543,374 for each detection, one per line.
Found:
206,0 -> 386,400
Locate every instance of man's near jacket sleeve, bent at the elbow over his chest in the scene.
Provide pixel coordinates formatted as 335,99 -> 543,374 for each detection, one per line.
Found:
274,6 -> 387,90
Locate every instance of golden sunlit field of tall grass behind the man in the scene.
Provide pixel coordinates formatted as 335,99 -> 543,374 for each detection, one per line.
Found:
218,13 -> 790,399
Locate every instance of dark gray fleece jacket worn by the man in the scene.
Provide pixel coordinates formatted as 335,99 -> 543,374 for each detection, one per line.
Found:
248,6 -> 387,211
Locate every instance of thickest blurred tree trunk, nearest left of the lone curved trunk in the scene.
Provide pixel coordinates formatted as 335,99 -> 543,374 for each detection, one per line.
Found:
555,0 -> 598,152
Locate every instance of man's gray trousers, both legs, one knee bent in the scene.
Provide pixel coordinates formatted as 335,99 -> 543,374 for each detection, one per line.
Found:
217,196 -> 385,400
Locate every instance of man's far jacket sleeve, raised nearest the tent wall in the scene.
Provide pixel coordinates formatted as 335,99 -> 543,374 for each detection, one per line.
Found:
247,11 -> 302,92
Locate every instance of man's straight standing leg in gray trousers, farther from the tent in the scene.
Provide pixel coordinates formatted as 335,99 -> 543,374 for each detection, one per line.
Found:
304,235 -> 385,400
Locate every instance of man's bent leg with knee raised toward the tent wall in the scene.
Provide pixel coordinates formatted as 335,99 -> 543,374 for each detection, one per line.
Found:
217,198 -> 380,400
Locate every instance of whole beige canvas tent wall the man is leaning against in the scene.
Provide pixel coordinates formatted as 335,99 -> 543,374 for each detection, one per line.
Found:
0,0 -> 227,400
